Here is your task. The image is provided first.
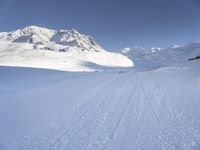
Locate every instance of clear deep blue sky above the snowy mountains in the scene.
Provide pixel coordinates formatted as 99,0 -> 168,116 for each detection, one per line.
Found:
0,0 -> 200,50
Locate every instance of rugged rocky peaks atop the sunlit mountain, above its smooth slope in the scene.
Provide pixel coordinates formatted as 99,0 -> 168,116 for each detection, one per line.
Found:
0,25 -> 104,52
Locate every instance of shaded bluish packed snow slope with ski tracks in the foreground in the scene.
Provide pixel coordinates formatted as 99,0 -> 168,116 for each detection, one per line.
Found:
0,62 -> 200,150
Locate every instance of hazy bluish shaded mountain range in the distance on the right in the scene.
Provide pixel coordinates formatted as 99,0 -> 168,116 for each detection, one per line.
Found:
121,43 -> 200,69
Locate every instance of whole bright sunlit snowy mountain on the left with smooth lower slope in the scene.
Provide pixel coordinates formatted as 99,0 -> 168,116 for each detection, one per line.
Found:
0,26 -> 134,71
